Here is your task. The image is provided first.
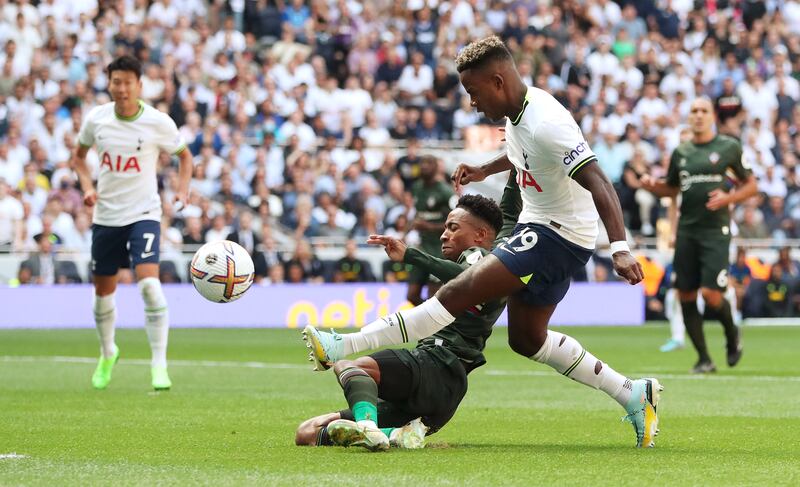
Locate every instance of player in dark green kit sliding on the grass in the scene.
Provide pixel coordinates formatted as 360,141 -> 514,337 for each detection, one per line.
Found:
295,194 -> 515,451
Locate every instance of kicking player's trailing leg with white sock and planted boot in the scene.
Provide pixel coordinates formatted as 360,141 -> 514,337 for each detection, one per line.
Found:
508,296 -> 662,447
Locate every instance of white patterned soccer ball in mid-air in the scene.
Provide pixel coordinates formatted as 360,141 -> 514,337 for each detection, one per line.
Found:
190,240 -> 254,303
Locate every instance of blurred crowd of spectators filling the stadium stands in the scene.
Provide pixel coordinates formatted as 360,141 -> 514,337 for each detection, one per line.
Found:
0,0 -> 800,315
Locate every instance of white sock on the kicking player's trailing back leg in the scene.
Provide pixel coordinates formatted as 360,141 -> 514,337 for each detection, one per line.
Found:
531,330 -> 633,407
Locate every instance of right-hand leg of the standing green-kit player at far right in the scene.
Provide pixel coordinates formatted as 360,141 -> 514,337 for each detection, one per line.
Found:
700,238 -> 742,367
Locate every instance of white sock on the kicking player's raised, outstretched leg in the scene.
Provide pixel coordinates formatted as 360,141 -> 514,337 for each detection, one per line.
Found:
342,296 -> 456,355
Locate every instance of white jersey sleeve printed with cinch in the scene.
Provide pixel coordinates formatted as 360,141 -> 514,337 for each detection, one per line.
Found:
533,121 -> 597,178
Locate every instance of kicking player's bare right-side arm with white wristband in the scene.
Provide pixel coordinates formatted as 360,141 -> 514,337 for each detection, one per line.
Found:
574,162 -> 644,284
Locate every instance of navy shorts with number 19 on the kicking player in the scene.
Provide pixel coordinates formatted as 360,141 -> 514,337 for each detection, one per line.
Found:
492,223 -> 594,306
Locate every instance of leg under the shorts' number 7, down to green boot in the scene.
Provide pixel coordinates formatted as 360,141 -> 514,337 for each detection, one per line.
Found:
130,220 -> 172,390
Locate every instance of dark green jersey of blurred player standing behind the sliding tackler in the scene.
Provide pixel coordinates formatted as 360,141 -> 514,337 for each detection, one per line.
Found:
411,181 -> 456,255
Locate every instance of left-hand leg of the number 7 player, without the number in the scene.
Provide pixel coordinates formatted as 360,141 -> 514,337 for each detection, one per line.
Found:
91,225 -> 128,389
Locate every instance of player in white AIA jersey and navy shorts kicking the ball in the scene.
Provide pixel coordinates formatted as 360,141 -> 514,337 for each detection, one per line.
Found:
305,36 -> 661,447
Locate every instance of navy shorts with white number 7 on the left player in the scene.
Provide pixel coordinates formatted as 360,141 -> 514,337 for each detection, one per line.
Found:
92,220 -> 161,276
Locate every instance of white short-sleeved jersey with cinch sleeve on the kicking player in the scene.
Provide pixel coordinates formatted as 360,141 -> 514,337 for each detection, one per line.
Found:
506,87 -> 599,249
